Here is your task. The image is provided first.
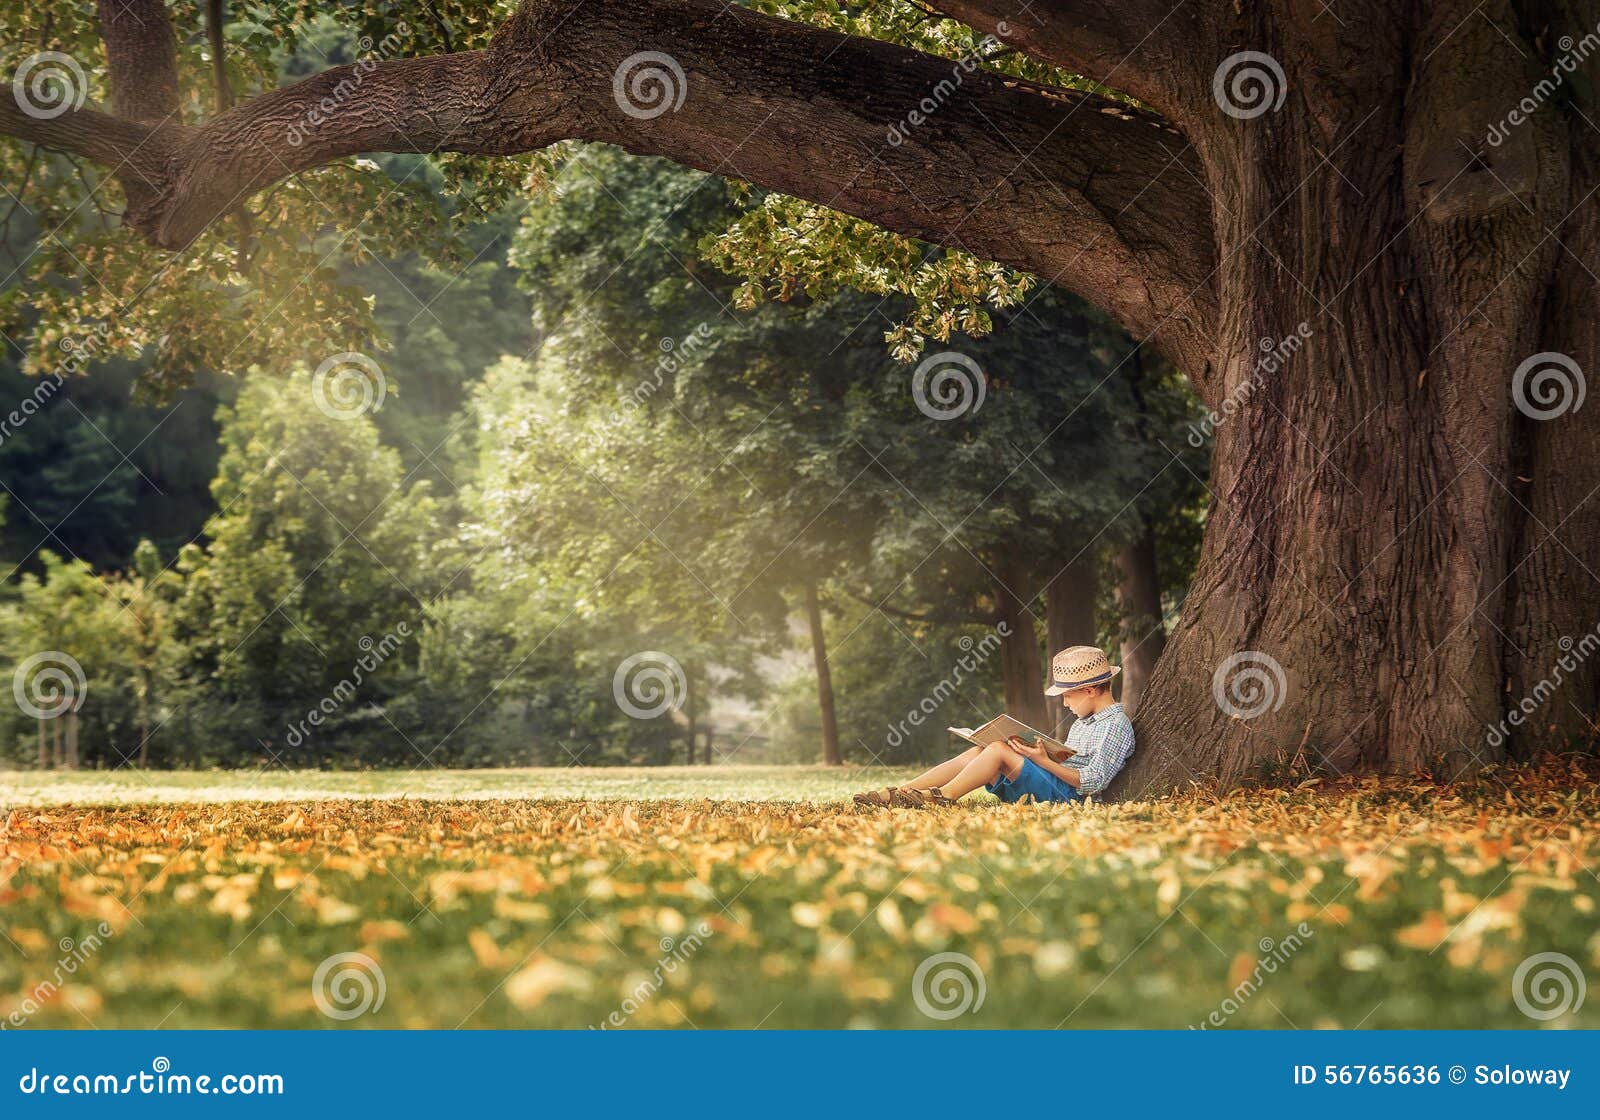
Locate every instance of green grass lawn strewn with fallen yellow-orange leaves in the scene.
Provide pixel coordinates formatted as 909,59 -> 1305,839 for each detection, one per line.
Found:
0,762 -> 1600,1027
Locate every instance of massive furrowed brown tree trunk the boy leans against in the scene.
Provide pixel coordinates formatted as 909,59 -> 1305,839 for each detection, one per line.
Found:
1117,2 -> 1600,794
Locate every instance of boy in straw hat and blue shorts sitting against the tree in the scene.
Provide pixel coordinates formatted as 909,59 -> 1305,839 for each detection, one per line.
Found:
856,645 -> 1133,808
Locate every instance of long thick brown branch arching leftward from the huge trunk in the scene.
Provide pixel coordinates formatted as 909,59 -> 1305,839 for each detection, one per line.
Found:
0,0 -> 1214,368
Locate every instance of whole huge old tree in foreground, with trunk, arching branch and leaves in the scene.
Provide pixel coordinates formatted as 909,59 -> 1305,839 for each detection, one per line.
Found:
9,0 -> 1600,790
